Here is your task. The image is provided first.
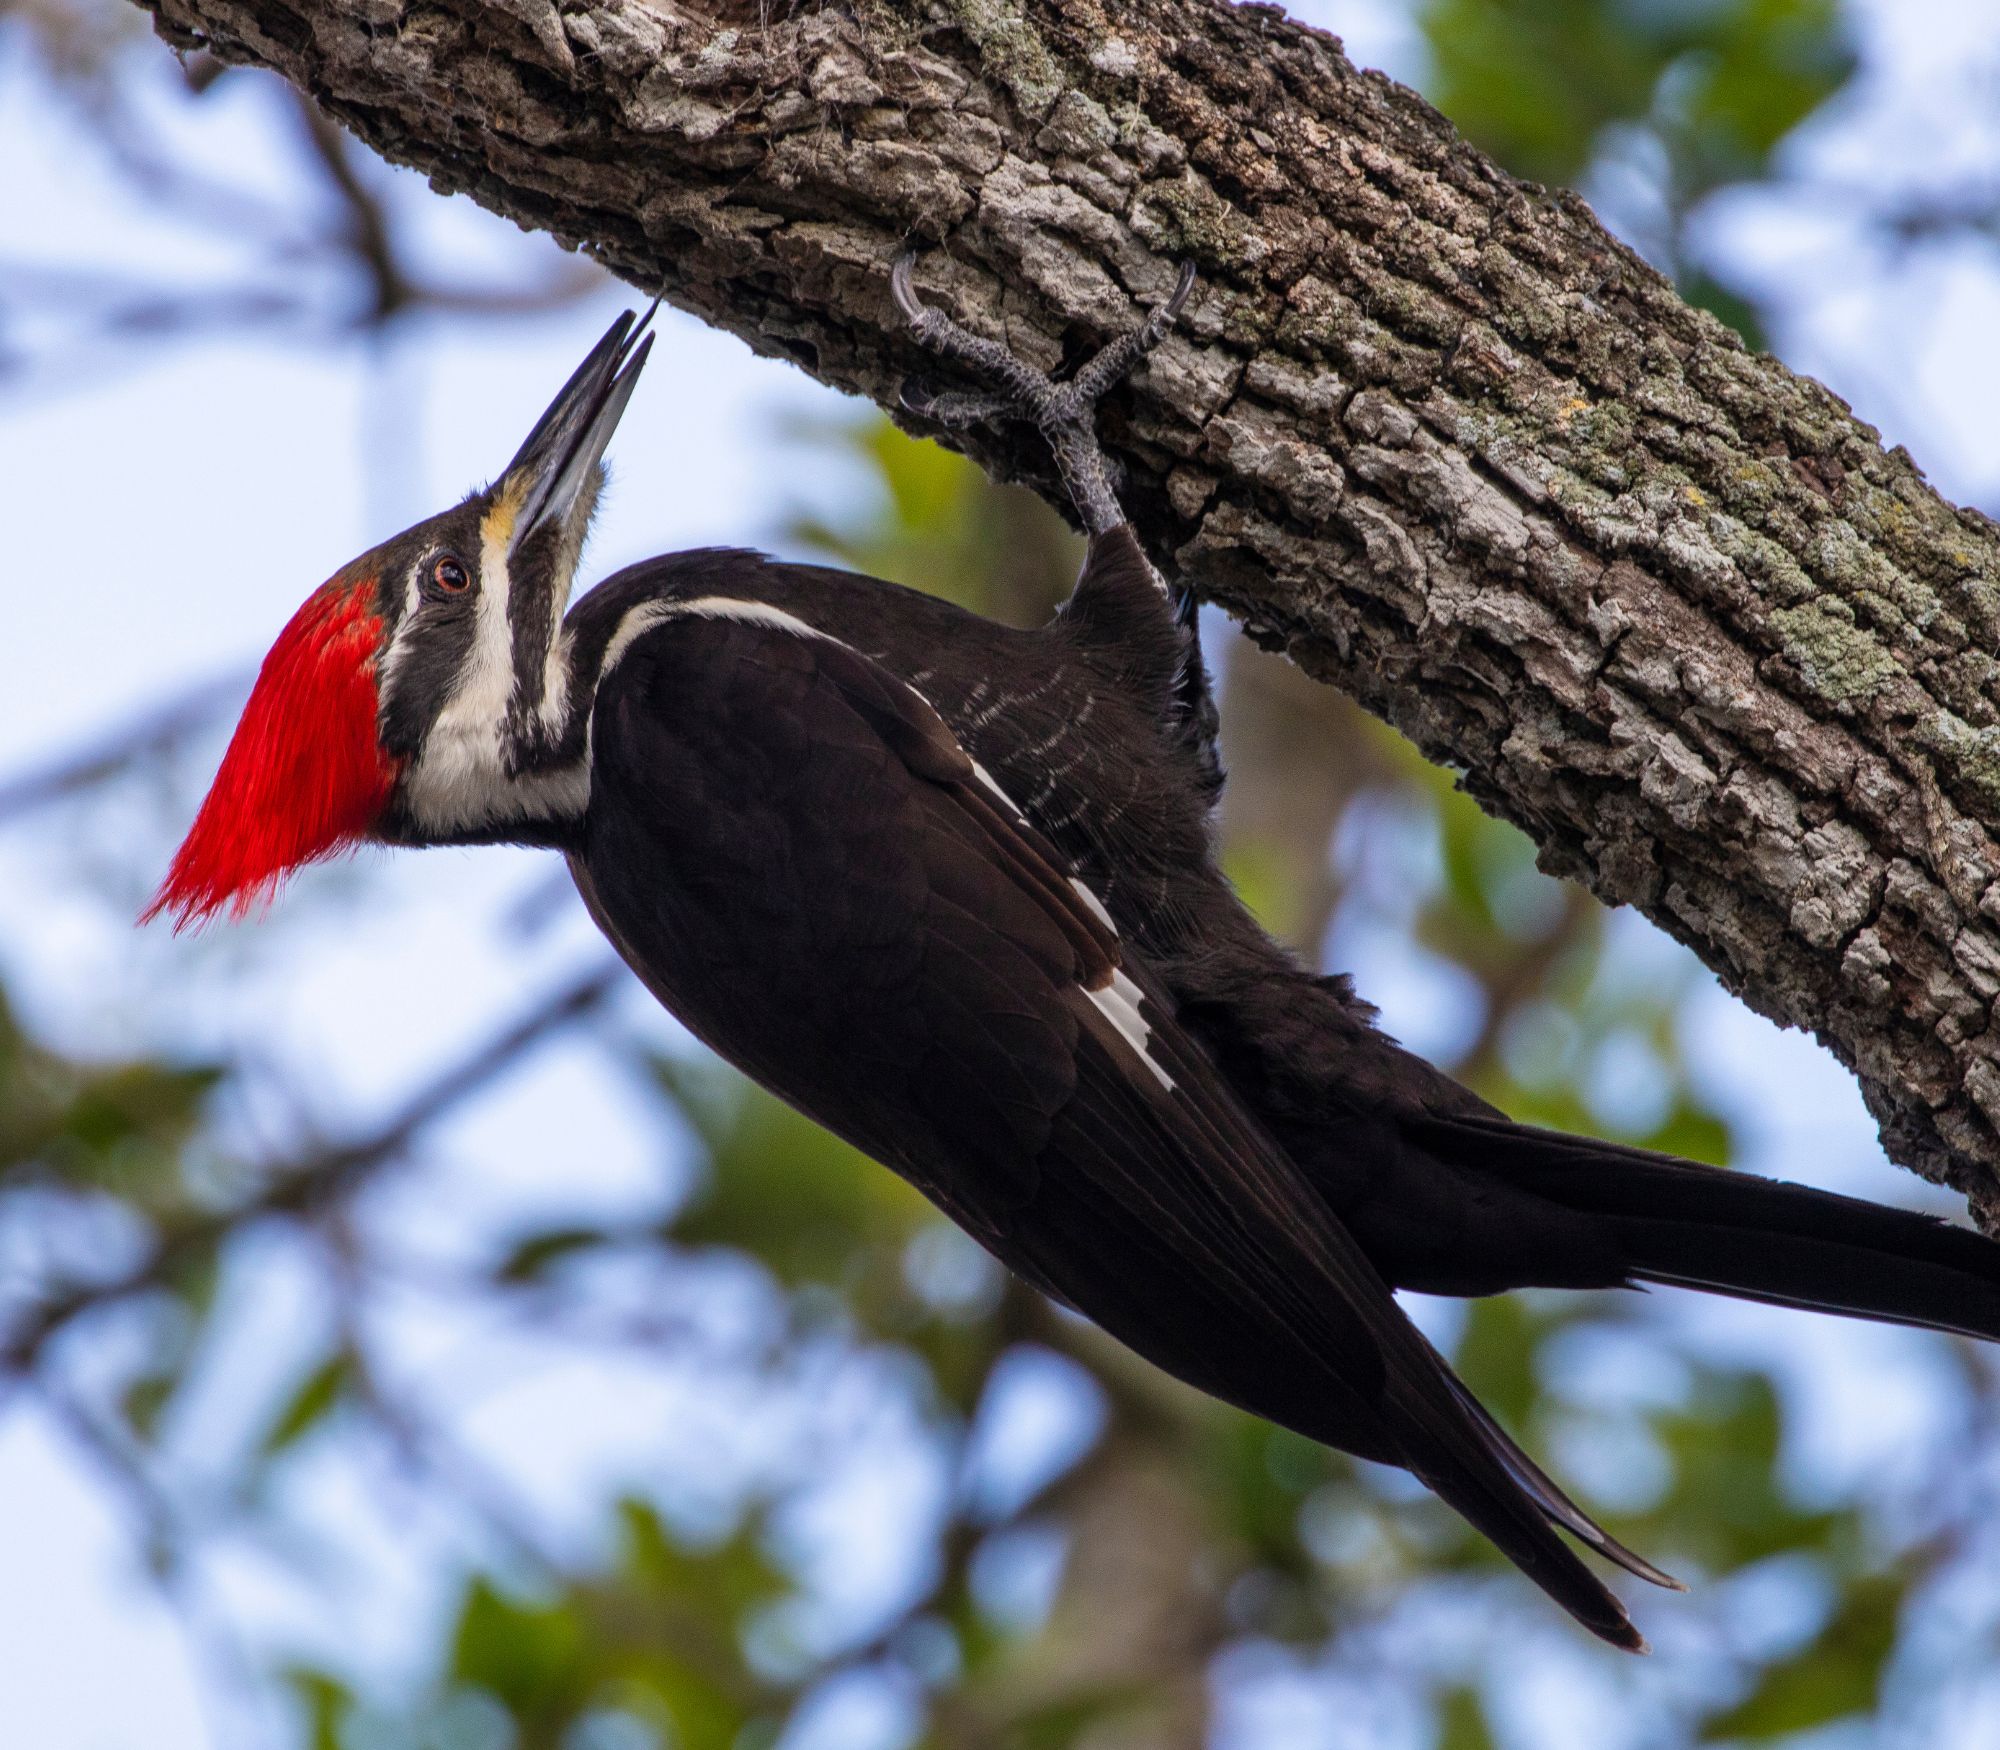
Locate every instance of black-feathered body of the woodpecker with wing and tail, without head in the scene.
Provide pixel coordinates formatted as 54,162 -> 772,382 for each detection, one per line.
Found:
552,528 -> 2000,1644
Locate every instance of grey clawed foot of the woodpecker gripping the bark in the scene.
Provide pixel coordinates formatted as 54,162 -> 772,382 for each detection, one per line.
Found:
888,256 -> 1194,534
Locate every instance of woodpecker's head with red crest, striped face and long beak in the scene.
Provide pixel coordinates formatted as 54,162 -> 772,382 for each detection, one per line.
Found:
146,312 -> 652,928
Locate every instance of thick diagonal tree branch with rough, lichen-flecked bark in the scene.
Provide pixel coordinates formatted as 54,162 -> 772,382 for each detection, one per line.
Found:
133,0 -> 2000,1220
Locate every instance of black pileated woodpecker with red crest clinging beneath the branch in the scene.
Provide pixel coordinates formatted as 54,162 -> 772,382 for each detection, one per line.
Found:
148,260 -> 2000,1648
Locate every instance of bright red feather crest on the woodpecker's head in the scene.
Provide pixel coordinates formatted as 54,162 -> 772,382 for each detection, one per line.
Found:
140,578 -> 400,930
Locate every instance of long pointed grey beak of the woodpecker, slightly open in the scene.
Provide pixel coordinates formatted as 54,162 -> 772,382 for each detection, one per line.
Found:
490,298 -> 660,558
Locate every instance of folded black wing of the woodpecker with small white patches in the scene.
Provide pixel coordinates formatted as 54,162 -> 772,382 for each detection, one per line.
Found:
572,600 -> 1654,1646
